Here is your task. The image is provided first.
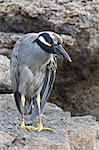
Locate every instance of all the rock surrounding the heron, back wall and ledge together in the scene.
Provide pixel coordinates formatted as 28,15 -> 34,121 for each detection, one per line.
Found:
0,0 -> 99,150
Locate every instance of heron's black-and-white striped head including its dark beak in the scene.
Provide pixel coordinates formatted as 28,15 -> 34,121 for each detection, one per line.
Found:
36,31 -> 72,62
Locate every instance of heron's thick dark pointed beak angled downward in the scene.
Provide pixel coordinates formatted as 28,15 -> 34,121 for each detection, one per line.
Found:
54,45 -> 72,62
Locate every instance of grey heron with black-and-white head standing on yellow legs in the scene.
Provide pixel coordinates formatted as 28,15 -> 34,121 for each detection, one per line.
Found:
11,31 -> 71,131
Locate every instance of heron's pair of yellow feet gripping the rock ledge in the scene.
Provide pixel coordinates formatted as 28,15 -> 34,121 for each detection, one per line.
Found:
22,124 -> 53,132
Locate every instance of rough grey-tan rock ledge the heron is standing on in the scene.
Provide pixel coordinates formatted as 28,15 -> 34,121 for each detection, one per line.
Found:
0,94 -> 99,150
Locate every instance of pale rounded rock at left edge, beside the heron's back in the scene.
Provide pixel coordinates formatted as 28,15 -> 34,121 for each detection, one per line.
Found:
0,55 -> 12,93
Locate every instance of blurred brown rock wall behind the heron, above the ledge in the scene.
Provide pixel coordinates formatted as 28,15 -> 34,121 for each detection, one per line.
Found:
0,0 -> 99,120
